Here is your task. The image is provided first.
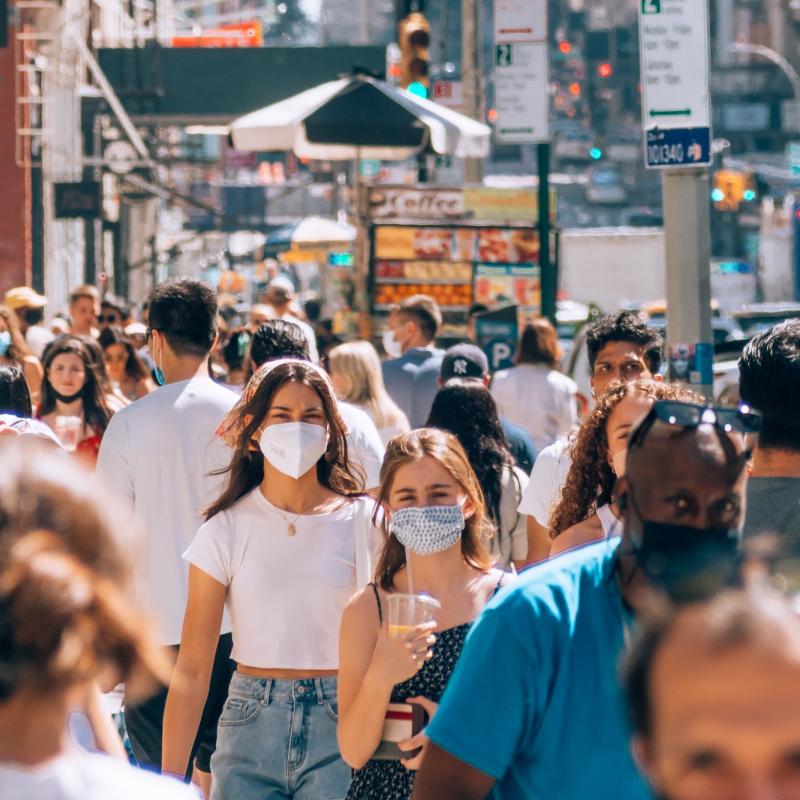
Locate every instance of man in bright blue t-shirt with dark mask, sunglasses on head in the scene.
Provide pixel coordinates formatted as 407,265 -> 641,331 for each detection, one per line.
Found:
414,396 -> 747,800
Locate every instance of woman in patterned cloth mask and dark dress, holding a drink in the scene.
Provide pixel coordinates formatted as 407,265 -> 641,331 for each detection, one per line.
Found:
338,428 -> 511,800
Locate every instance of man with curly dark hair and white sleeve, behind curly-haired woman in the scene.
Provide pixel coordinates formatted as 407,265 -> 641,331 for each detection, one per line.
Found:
519,311 -> 663,563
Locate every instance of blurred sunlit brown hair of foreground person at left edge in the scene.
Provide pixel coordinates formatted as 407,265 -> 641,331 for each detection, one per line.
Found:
0,439 -> 170,702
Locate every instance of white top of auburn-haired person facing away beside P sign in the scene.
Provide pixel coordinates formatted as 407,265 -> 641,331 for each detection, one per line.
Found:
492,364 -> 578,453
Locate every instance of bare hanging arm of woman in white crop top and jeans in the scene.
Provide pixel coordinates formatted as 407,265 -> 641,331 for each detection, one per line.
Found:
161,565 -> 227,776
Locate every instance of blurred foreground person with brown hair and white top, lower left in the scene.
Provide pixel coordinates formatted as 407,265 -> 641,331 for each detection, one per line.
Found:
0,437 -> 195,800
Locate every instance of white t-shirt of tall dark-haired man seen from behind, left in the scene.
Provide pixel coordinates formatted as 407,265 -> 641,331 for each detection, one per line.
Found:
97,376 -> 237,644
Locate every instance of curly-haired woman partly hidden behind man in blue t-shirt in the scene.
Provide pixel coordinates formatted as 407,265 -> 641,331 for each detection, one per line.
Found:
550,381 -> 702,557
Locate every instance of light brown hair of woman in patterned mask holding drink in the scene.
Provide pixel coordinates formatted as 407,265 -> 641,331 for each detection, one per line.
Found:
375,428 -> 493,591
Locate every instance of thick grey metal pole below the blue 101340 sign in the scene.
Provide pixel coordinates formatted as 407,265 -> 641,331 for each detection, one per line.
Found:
662,170 -> 714,399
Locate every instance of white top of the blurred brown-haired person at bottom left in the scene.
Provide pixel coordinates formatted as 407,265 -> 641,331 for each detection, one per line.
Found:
0,751 -> 200,800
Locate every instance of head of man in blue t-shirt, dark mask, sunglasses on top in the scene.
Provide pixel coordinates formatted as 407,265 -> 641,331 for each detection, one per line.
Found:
616,401 -> 760,606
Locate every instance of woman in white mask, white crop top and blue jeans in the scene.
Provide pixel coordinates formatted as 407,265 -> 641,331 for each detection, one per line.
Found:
162,360 -> 375,800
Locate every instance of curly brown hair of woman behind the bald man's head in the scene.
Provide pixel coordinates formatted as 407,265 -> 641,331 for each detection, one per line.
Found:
550,381 -> 703,539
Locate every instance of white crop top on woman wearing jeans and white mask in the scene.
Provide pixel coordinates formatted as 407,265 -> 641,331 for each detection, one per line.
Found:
184,488 -> 375,670
